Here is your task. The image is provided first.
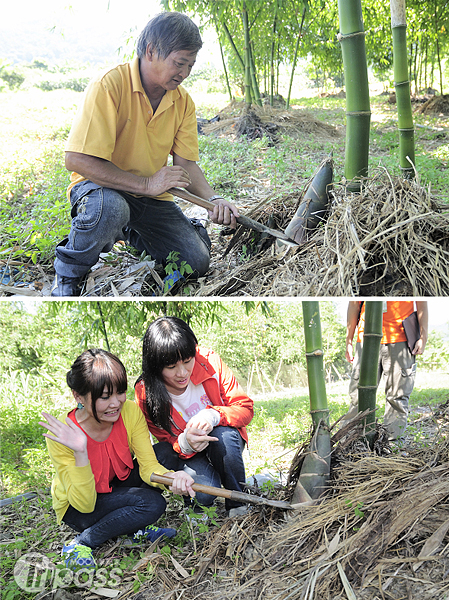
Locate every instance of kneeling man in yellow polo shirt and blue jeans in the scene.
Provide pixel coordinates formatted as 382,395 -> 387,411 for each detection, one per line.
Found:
51,12 -> 238,296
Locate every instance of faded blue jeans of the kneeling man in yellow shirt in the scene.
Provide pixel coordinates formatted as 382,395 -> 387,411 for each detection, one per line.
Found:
55,181 -> 210,277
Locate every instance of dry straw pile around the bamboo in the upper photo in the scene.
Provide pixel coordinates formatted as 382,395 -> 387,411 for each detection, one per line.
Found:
195,169 -> 449,296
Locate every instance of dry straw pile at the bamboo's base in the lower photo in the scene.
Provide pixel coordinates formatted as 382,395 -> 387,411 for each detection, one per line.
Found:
139,404 -> 449,600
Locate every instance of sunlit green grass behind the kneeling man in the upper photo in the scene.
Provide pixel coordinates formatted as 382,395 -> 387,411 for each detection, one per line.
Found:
0,80 -> 449,268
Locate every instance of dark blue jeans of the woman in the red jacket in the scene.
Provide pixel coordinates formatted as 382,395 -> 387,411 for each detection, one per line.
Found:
153,425 -> 245,510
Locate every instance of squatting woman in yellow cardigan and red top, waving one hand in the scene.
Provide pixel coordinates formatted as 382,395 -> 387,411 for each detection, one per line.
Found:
39,349 -> 195,569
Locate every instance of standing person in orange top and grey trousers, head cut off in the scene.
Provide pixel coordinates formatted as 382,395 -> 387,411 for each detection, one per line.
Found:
342,300 -> 428,440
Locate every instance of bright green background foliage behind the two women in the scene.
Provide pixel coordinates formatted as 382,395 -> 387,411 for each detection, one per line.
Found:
0,300 -> 449,496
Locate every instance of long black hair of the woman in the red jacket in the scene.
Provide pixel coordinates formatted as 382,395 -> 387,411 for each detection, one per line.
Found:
138,317 -> 198,435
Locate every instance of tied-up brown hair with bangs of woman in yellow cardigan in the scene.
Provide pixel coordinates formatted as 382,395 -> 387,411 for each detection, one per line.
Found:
66,348 -> 128,422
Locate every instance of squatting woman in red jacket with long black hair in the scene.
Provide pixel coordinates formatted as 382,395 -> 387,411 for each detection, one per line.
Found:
135,317 -> 253,517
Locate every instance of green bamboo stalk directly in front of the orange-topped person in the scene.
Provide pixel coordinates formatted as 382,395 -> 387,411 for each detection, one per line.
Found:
358,301 -> 383,445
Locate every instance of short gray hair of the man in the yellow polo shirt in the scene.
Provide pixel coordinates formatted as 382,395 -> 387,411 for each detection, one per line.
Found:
137,12 -> 203,60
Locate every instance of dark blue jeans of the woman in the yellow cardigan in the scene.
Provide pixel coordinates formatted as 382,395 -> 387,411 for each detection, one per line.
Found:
62,461 -> 166,548
